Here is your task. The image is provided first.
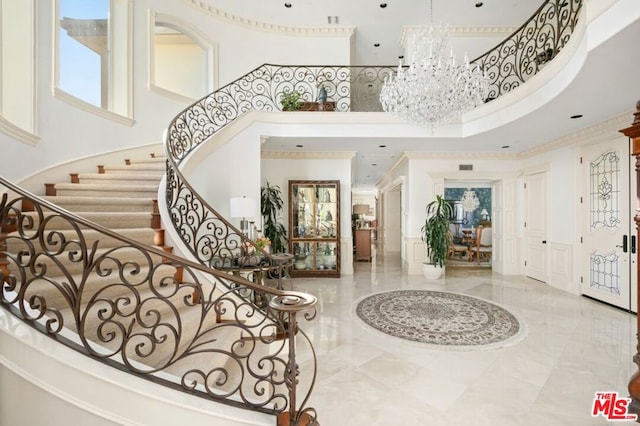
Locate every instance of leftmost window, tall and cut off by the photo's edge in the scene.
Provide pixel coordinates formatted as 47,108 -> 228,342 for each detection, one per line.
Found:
0,0 -> 36,142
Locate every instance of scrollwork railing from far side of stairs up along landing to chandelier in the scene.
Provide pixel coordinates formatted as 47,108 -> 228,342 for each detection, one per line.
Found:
165,64 -> 392,267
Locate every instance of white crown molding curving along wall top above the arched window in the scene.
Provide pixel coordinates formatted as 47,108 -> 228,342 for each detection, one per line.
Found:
184,0 -> 356,37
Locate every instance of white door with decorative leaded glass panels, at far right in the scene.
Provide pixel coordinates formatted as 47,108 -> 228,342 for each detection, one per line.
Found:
580,138 -> 637,311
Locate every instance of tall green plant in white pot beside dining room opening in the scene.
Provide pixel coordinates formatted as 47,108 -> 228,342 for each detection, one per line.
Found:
421,195 -> 453,279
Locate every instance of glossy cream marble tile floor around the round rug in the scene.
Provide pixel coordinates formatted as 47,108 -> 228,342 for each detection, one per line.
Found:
292,251 -> 636,426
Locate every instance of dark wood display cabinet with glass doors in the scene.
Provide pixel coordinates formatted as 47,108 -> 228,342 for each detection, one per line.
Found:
289,180 -> 340,277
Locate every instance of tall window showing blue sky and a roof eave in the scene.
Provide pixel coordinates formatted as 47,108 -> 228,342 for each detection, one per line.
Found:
55,0 -> 132,117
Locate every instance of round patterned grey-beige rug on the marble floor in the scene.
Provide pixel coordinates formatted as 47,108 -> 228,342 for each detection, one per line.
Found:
356,290 -> 526,350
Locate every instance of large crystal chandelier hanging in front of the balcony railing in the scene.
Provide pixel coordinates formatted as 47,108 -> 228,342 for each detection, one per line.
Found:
380,0 -> 489,132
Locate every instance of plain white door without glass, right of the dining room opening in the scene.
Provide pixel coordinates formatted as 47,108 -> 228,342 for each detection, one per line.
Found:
524,173 -> 547,282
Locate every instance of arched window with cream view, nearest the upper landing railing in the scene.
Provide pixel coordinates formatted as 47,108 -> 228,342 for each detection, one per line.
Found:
149,15 -> 216,100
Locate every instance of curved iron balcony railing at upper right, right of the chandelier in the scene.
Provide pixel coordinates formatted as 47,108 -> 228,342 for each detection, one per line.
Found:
473,0 -> 583,100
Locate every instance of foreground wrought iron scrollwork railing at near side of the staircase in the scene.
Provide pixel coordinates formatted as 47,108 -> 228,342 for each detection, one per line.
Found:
0,177 -> 316,424
